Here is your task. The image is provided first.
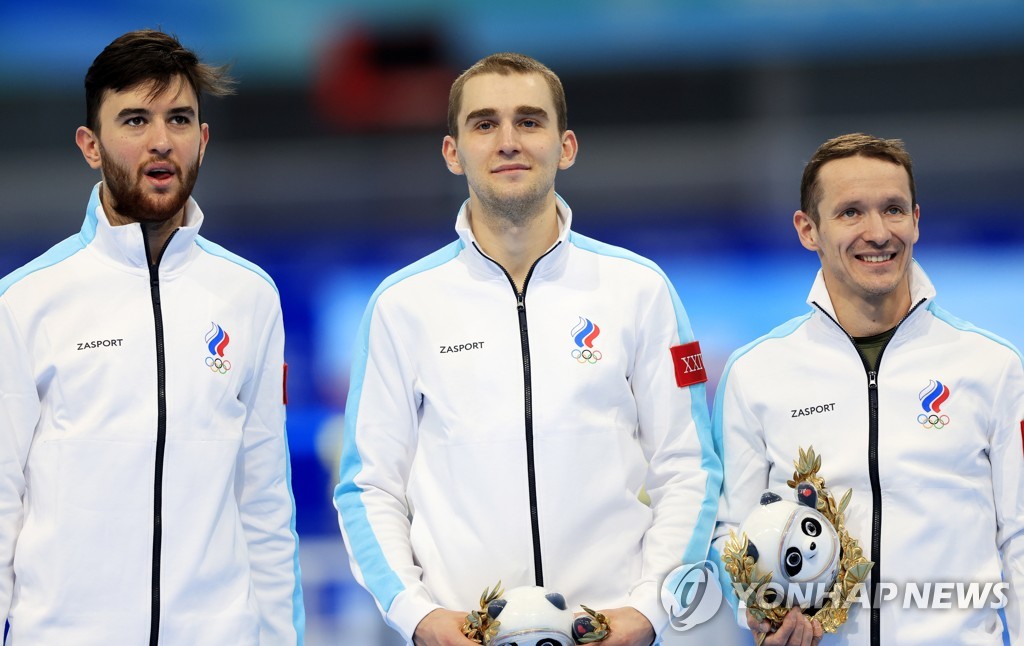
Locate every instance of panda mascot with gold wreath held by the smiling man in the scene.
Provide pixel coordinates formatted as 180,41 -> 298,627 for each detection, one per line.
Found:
722,446 -> 873,644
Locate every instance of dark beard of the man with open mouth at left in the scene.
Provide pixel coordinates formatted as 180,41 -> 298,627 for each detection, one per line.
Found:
100,147 -> 199,222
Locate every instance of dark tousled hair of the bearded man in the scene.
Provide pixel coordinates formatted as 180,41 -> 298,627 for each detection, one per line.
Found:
85,30 -> 234,132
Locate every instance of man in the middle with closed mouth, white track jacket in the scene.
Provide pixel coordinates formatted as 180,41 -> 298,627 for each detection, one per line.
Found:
335,53 -> 721,646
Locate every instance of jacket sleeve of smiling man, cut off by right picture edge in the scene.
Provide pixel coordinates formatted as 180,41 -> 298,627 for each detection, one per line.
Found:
988,348 -> 1024,644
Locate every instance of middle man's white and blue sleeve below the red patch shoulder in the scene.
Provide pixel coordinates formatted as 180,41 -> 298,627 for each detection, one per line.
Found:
630,274 -> 722,635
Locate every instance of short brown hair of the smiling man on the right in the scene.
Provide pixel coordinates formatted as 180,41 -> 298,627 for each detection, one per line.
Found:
800,132 -> 918,225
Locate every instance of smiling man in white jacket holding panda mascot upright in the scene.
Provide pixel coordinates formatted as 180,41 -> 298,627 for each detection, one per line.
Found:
714,134 -> 1024,646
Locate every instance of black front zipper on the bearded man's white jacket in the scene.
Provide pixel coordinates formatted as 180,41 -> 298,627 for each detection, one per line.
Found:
142,225 -> 177,646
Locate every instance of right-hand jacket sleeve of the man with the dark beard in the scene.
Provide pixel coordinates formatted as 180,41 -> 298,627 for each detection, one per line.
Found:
236,299 -> 305,644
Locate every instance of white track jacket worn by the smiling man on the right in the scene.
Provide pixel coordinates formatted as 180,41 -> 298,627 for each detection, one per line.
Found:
714,263 -> 1024,646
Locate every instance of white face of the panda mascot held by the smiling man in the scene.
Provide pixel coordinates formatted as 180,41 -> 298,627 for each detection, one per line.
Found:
778,506 -> 839,583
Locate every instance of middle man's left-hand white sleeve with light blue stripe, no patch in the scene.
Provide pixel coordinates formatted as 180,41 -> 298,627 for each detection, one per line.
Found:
334,290 -> 439,642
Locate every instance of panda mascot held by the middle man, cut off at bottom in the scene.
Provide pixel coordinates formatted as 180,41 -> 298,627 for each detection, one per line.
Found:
462,582 -> 609,646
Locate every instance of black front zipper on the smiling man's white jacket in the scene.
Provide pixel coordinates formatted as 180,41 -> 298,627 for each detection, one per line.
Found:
814,298 -> 927,646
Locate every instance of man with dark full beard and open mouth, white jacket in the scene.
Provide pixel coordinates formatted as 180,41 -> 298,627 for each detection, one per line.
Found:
0,31 -> 304,645
